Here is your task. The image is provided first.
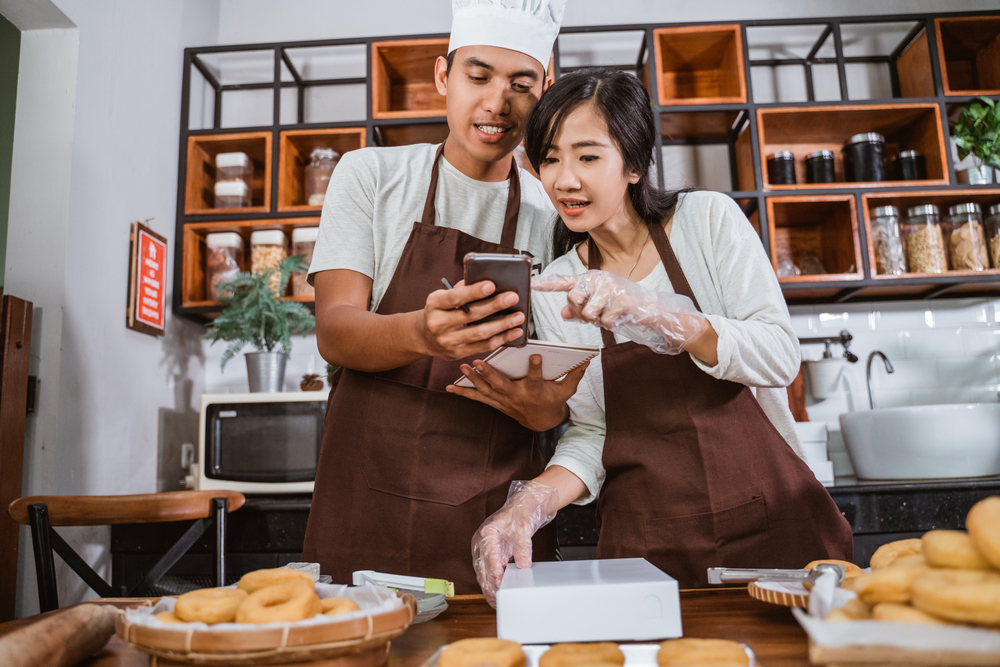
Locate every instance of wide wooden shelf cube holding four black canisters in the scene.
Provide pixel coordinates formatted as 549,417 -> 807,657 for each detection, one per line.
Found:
757,103 -> 948,190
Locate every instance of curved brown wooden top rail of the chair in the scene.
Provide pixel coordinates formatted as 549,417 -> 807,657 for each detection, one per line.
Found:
7,491 -> 246,526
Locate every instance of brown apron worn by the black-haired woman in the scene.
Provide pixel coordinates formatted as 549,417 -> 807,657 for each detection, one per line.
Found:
589,218 -> 854,588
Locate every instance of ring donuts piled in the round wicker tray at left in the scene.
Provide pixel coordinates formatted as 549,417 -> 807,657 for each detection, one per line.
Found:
156,568 -> 361,625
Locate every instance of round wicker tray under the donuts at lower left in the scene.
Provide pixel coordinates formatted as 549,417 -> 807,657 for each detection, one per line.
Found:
115,595 -> 417,667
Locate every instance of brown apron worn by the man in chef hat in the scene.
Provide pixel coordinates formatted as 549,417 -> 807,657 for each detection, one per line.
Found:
302,144 -> 555,594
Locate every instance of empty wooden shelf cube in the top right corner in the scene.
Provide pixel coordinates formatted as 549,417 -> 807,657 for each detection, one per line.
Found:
934,16 -> 1000,95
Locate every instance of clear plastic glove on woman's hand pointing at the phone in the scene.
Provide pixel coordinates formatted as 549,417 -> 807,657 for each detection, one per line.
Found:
531,271 -> 706,354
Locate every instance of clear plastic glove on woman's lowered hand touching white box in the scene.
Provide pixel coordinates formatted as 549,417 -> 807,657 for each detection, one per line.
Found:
472,481 -> 559,609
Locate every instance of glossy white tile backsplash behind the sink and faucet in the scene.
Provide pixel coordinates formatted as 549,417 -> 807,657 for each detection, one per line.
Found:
789,299 -> 1000,422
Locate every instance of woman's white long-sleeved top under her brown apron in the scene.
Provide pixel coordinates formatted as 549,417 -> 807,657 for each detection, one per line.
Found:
531,192 -> 803,505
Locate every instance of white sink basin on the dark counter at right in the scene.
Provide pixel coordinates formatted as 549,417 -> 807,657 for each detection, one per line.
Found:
840,403 -> 1000,479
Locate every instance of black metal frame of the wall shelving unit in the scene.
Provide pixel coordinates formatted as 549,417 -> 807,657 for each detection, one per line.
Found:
173,11 -> 1000,318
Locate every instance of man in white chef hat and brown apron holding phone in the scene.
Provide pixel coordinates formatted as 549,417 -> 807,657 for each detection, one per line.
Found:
303,0 -> 583,593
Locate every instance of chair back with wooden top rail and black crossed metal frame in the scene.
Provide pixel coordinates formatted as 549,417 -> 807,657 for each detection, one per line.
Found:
7,491 -> 246,611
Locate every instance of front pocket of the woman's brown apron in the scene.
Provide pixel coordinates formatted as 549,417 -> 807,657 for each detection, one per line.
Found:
643,495 -> 772,582
